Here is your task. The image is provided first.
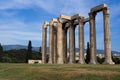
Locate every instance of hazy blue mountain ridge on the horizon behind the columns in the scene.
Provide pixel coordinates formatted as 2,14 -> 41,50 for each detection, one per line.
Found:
3,45 -> 120,54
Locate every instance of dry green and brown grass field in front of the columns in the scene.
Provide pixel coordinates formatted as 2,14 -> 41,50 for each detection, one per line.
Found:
0,64 -> 120,80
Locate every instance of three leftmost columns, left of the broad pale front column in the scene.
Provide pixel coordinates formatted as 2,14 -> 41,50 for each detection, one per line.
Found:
42,23 -> 57,64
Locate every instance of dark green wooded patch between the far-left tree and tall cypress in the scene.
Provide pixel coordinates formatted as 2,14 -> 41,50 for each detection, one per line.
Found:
2,49 -> 27,63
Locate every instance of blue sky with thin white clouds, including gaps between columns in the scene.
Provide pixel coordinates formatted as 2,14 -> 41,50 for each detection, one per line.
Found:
0,0 -> 120,51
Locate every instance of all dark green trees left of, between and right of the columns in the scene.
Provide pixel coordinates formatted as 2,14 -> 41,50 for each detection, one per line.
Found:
0,41 -> 120,64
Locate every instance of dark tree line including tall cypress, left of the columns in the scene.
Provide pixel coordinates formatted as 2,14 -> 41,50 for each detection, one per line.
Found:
0,41 -> 42,63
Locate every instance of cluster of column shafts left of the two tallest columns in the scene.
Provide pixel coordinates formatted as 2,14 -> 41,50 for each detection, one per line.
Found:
42,18 -> 84,64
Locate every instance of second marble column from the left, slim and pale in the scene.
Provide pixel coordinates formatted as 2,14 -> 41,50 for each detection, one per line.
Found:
48,26 -> 54,64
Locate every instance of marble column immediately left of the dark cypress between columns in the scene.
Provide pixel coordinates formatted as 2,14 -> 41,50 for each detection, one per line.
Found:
79,17 -> 85,64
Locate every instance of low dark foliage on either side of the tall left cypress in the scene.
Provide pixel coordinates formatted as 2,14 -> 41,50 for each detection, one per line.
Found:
2,49 -> 42,63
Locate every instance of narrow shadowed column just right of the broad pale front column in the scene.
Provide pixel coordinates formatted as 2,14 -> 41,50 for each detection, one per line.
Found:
63,29 -> 67,63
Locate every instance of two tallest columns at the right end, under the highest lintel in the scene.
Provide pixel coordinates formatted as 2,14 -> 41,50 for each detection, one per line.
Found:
89,8 -> 114,64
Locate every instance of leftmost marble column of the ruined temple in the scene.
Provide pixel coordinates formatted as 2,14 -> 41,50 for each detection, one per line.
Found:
42,26 -> 47,64
